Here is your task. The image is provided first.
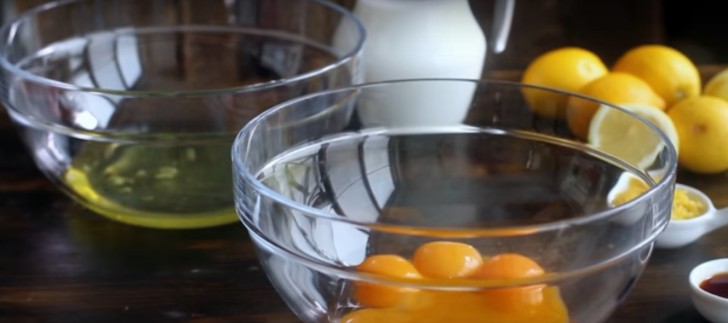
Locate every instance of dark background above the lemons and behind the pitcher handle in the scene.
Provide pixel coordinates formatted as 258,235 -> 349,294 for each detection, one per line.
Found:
0,0 -> 728,124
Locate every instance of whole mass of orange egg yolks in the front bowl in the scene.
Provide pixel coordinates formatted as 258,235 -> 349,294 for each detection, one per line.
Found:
348,241 -> 569,323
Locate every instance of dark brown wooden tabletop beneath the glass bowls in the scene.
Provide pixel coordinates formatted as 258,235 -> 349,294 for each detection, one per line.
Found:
0,118 -> 728,323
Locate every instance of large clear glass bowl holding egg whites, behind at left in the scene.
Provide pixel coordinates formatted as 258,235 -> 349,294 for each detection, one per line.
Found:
0,0 -> 365,228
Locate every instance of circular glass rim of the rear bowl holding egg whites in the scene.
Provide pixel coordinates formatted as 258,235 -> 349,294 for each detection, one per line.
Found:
0,0 -> 367,97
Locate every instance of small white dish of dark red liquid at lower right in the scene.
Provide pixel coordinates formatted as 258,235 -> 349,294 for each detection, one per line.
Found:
688,258 -> 728,323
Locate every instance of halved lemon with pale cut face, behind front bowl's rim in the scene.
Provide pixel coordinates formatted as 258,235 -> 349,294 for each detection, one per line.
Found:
588,104 -> 679,169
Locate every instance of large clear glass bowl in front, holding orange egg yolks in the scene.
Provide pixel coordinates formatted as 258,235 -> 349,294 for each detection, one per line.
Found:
232,80 -> 676,322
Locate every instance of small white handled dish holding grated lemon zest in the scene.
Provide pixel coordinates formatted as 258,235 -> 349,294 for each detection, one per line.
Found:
655,184 -> 728,249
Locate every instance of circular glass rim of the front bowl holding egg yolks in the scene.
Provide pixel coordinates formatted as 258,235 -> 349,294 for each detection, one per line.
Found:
231,78 -> 677,240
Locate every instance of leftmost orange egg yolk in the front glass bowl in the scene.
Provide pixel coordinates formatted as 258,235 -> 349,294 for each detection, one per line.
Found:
355,255 -> 421,307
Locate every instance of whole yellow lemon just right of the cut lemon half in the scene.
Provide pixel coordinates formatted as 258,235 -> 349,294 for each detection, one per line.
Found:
668,96 -> 728,174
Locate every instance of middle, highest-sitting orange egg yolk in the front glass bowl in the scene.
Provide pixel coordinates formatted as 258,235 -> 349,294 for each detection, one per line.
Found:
412,241 -> 483,278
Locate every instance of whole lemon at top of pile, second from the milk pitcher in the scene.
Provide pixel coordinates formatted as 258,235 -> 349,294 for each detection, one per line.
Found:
612,45 -> 700,106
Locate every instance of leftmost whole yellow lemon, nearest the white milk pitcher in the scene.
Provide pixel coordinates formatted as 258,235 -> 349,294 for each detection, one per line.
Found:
521,47 -> 608,118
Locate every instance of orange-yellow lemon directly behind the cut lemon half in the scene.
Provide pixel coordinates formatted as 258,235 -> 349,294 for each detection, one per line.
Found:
566,72 -> 665,138
